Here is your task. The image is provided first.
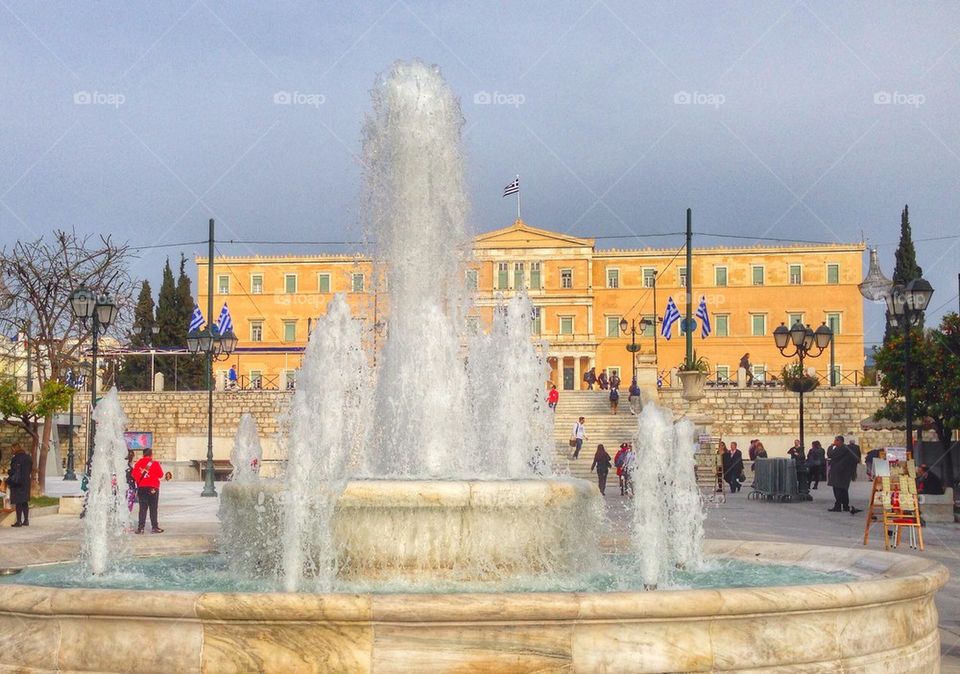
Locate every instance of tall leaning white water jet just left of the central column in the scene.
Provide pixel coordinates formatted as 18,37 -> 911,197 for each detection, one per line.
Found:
280,294 -> 371,592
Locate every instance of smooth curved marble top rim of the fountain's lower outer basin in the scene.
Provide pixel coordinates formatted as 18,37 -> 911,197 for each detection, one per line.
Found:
0,540 -> 949,623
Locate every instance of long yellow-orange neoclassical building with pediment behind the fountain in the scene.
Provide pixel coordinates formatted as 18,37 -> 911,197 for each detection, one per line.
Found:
196,220 -> 865,390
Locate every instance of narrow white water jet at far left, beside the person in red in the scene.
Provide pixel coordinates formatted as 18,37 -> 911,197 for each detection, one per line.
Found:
80,387 -> 128,575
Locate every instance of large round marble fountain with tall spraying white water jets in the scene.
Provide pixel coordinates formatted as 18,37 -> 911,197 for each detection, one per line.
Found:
0,62 -> 946,674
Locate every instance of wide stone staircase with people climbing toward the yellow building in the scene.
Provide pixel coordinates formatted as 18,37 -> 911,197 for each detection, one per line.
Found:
553,391 -> 637,484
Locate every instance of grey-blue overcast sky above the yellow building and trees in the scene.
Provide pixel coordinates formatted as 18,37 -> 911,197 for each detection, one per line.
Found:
0,0 -> 960,342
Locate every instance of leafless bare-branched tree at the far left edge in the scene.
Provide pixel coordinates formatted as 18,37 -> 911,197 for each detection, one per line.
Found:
0,230 -> 133,493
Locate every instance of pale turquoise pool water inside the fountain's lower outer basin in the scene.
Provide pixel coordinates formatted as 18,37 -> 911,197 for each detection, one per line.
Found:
0,554 -> 855,594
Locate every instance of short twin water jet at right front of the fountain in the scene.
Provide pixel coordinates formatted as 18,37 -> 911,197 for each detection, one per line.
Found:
631,404 -> 704,588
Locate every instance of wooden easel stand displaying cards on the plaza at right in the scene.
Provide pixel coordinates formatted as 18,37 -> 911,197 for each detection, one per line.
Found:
863,451 -> 923,551
